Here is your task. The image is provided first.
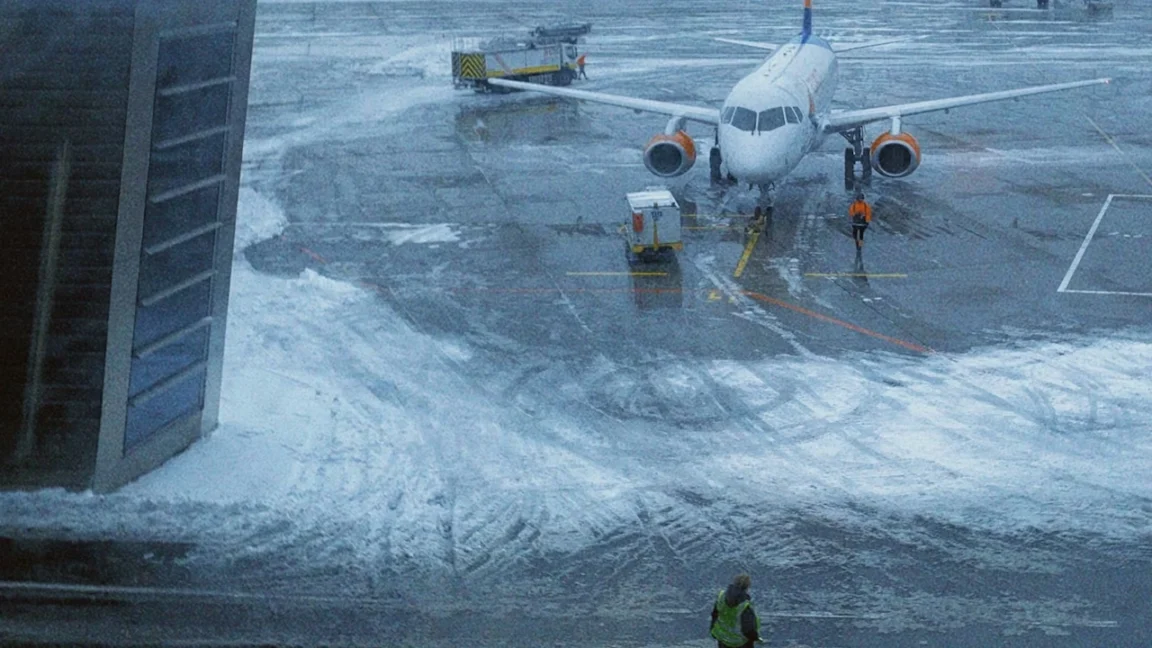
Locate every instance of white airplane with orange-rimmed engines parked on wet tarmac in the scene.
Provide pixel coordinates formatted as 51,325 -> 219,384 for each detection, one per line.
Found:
488,0 -> 1111,204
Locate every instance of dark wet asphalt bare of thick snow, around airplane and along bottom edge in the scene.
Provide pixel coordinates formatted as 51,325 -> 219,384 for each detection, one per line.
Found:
0,0 -> 1152,647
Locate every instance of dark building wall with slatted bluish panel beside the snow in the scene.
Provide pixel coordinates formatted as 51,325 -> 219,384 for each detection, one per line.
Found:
0,0 -> 255,489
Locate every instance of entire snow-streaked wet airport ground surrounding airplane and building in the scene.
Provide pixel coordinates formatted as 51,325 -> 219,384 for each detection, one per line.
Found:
0,0 -> 1152,646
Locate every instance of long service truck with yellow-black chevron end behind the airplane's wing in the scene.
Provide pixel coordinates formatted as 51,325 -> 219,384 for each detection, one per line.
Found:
452,23 -> 592,92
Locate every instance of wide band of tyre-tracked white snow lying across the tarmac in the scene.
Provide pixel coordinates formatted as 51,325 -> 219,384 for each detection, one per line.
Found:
0,190 -> 1152,574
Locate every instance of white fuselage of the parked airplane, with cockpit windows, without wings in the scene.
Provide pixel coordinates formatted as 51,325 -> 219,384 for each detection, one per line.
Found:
718,35 -> 838,184
